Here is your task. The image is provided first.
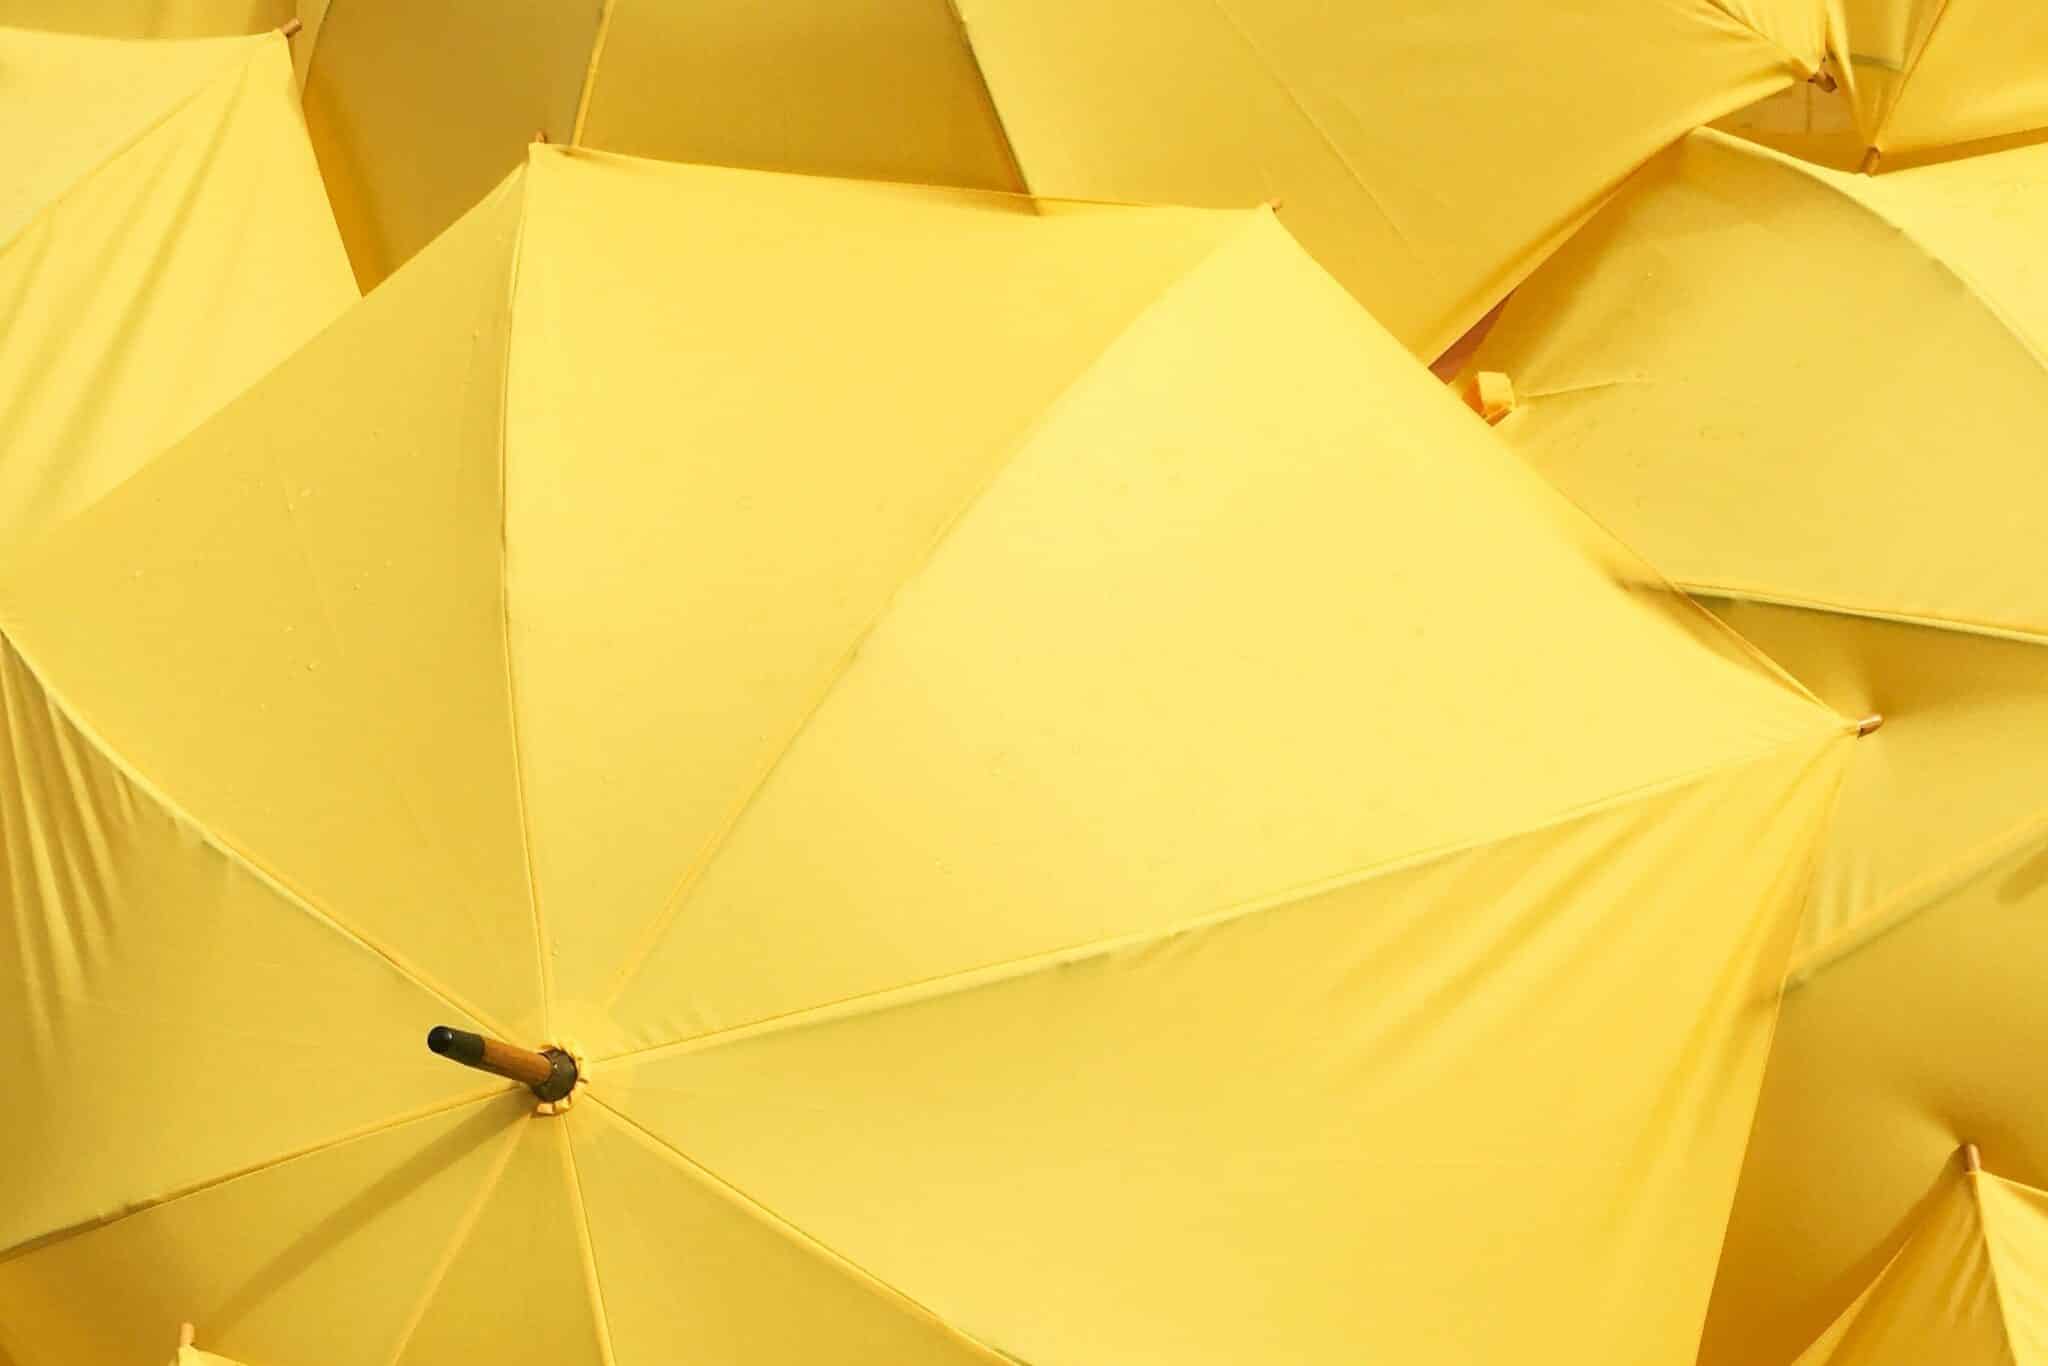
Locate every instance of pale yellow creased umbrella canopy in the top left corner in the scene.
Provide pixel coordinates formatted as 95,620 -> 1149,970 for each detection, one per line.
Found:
0,29 -> 354,545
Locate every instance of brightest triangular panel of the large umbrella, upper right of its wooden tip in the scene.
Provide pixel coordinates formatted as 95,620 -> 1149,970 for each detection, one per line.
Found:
598,208 -> 1833,1047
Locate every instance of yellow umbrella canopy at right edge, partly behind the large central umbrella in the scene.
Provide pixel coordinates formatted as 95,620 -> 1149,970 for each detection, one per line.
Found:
1479,133 -> 2048,1362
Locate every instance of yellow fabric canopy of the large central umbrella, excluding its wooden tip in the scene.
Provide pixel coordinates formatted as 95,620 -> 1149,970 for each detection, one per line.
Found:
0,147 -> 1853,1366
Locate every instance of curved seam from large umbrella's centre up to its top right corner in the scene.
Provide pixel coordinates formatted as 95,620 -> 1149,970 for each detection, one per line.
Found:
585,207 -> 1278,1008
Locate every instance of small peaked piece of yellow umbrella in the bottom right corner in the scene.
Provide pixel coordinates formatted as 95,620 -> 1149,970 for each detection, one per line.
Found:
1796,1163 -> 2048,1366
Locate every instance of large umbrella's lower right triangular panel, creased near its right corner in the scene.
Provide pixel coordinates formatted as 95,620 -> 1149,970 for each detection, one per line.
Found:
592,750 -> 1835,1366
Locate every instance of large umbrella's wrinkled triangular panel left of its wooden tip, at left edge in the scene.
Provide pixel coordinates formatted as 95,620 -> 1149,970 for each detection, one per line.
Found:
0,641 -> 503,1269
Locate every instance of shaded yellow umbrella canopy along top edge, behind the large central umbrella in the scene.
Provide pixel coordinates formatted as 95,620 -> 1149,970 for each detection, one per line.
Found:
305,0 -> 1831,356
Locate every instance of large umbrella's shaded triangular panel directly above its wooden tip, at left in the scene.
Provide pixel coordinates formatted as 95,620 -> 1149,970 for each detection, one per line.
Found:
0,174 -> 541,1036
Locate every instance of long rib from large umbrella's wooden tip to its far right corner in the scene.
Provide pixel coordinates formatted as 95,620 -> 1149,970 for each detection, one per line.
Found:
592,723 -> 1851,1065
